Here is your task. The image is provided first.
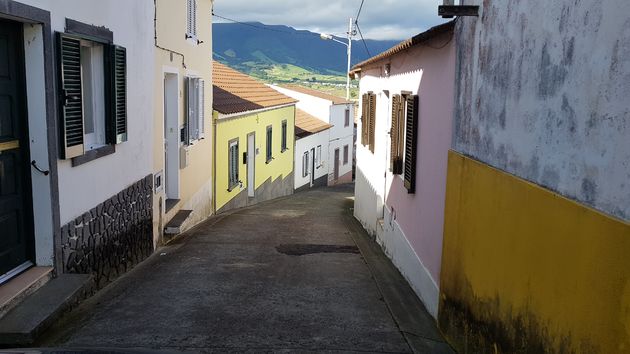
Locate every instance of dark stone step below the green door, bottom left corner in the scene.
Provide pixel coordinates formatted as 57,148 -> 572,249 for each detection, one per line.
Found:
0,273 -> 93,346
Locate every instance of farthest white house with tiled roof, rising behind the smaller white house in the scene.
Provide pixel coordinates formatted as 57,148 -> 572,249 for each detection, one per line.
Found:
273,85 -> 355,185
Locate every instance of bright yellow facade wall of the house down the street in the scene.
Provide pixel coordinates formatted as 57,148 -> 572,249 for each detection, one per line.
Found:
214,106 -> 295,210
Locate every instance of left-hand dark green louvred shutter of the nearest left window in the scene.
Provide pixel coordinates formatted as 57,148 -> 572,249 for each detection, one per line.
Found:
57,33 -> 84,159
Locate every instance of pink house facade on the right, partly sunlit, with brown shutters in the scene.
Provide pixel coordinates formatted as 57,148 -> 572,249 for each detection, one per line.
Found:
350,22 -> 456,318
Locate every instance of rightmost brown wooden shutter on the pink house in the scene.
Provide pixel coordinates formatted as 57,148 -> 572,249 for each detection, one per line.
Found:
404,95 -> 419,193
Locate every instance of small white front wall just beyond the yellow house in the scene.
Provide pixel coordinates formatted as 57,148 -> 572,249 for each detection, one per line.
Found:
294,129 -> 330,189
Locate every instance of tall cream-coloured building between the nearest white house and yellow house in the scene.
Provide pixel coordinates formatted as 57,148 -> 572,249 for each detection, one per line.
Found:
153,0 -> 213,244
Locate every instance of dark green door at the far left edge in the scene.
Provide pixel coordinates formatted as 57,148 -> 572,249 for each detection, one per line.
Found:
0,21 -> 34,281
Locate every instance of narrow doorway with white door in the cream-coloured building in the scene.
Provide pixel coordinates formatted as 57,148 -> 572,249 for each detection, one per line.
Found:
164,73 -> 179,206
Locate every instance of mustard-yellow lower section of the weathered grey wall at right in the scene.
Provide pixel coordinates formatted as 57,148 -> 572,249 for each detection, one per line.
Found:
439,152 -> 630,353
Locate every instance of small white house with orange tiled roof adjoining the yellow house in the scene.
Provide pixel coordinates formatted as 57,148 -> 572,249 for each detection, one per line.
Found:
295,108 -> 332,191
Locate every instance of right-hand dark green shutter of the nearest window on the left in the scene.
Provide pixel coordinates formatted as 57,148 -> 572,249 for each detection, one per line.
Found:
110,46 -> 128,144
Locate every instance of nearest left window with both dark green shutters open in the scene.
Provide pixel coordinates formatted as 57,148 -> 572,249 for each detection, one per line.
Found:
57,32 -> 127,162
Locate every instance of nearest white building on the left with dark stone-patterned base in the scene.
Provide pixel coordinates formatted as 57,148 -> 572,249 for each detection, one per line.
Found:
0,0 -> 154,332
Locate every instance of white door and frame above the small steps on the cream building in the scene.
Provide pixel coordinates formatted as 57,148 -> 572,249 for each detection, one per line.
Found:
162,67 -> 181,199
